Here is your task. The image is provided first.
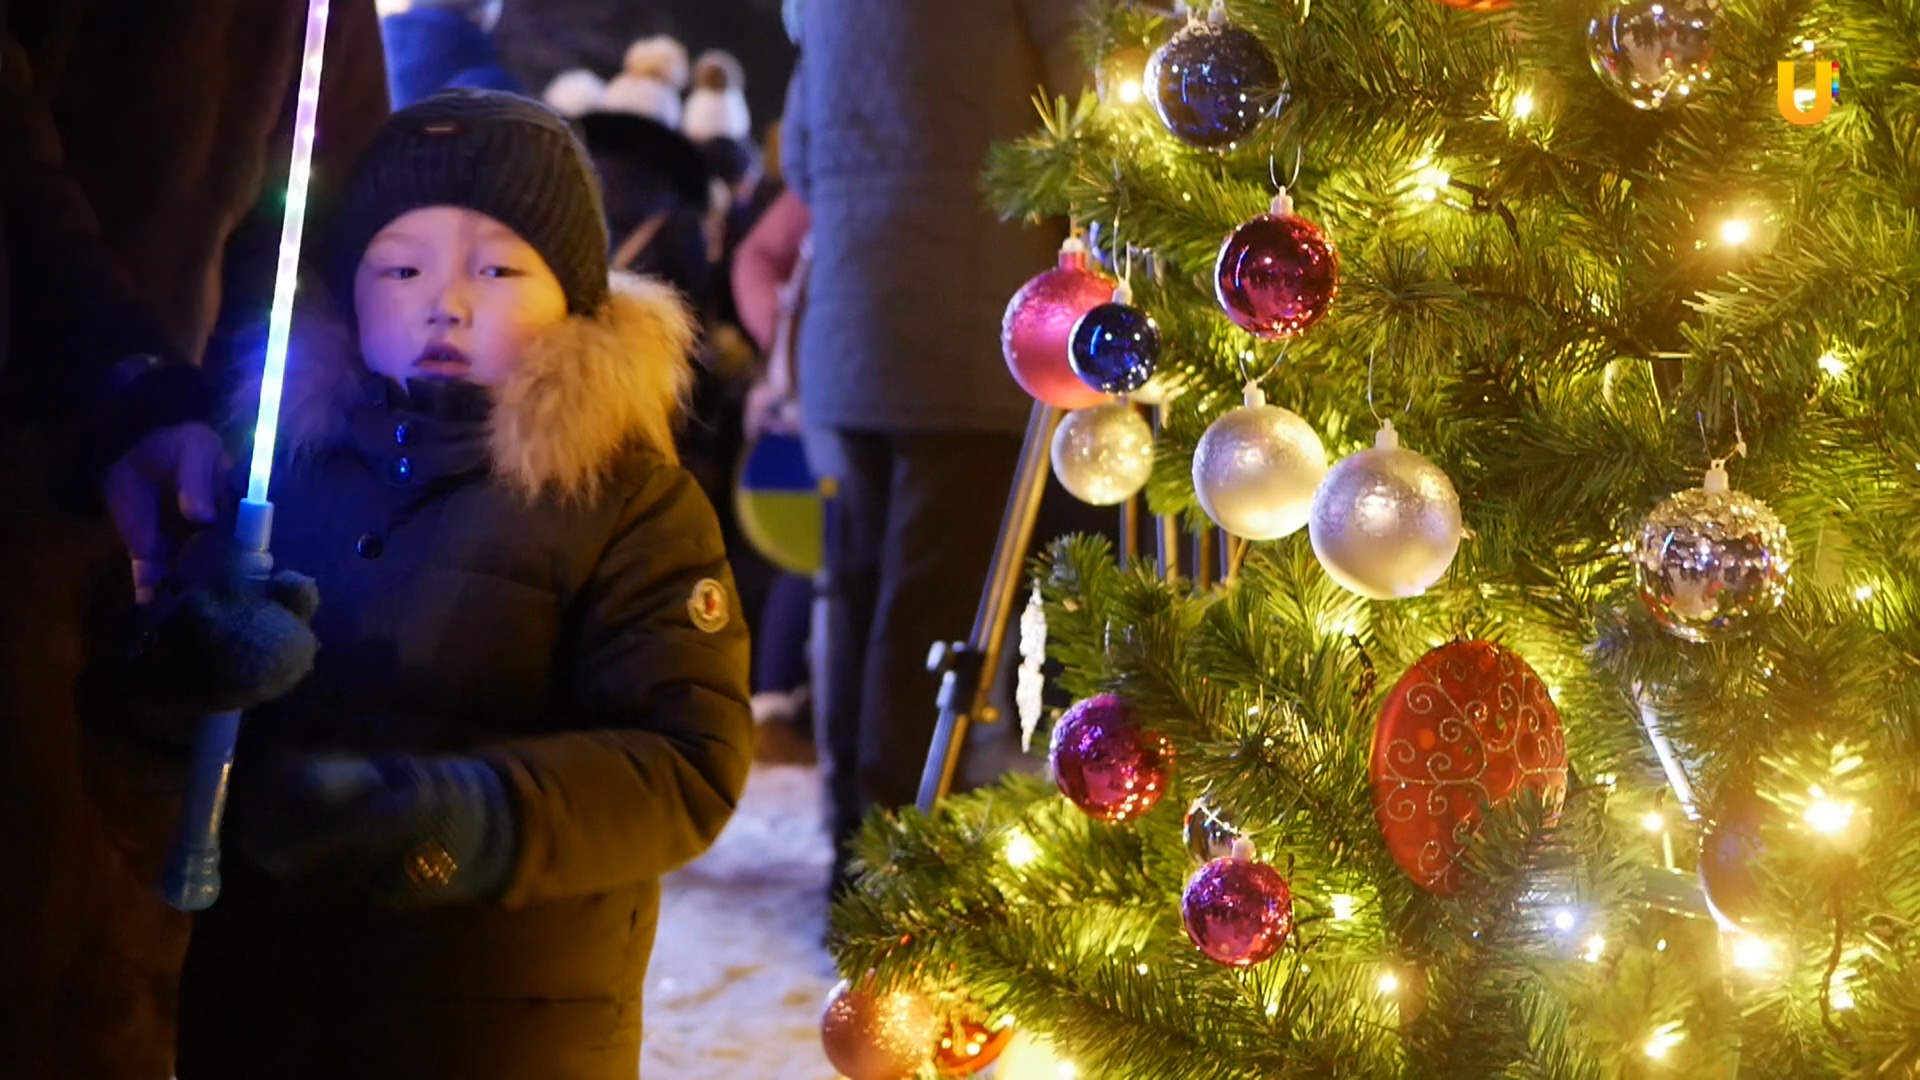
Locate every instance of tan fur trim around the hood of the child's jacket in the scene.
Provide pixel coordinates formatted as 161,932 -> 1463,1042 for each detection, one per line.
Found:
243,273 -> 695,500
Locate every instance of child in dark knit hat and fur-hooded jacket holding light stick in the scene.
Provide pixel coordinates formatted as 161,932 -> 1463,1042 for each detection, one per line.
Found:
153,90 -> 753,1080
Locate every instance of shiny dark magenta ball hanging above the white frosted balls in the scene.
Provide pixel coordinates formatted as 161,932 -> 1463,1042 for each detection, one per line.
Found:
1213,192 -> 1340,340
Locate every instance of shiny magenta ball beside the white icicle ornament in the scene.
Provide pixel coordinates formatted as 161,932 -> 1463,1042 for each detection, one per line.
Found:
1046,694 -> 1173,822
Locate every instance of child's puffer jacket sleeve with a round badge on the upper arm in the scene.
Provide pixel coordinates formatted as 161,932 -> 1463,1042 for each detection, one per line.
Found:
482,467 -> 753,907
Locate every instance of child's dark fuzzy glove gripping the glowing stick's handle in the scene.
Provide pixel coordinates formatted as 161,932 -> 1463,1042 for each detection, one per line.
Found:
129,571 -> 321,746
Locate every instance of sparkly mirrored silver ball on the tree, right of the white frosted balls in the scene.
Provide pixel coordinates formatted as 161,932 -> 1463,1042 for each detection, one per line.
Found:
1634,461 -> 1793,642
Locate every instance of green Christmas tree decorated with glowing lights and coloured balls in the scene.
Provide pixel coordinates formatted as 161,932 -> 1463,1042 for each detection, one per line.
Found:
826,0 -> 1920,1080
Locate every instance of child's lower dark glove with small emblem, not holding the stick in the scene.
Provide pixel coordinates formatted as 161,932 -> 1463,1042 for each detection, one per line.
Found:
232,755 -> 516,907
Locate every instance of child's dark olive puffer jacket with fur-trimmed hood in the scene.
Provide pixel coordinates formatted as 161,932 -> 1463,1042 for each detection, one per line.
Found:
179,270 -> 753,1080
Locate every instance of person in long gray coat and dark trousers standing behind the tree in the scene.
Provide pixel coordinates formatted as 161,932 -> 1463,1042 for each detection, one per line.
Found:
783,0 -> 1087,888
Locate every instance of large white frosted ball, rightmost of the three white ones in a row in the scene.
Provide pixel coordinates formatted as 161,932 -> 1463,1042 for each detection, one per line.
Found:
1308,421 -> 1463,600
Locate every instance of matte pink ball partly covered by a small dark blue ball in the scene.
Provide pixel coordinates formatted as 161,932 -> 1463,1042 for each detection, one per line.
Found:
1000,238 -> 1114,411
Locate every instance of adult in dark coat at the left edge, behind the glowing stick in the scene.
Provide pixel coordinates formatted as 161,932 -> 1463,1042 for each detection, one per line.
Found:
0,0 -> 386,1080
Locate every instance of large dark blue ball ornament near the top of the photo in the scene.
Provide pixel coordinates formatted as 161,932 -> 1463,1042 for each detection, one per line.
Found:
1146,15 -> 1281,150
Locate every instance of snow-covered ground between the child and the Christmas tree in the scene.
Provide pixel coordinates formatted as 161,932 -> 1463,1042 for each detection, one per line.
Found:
639,763 -> 837,1080
